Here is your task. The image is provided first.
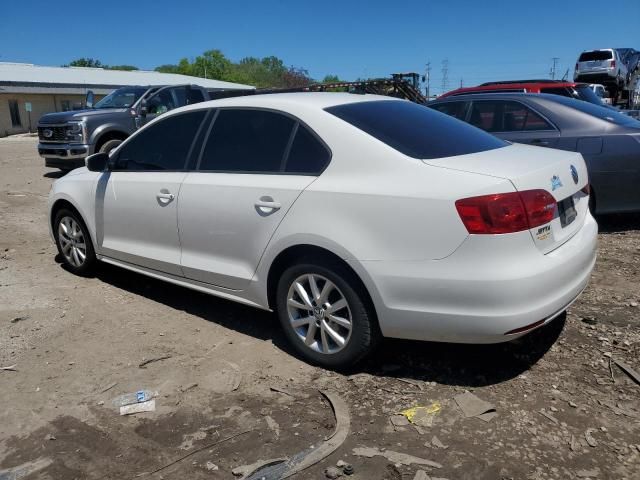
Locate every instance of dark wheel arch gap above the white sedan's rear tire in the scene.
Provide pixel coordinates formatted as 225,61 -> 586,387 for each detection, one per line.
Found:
266,243 -> 380,328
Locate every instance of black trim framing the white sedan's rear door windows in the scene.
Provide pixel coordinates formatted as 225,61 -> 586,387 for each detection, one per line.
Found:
193,106 -> 333,177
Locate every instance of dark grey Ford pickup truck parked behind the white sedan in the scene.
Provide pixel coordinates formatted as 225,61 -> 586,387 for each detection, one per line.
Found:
38,85 -> 211,170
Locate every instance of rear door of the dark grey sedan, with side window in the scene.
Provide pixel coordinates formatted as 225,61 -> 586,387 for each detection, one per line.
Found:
469,100 -> 560,147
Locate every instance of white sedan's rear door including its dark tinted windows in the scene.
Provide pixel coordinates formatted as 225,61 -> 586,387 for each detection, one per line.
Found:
178,108 -> 330,290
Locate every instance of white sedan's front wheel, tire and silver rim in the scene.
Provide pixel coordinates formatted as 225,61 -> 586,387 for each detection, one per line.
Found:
53,208 -> 96,276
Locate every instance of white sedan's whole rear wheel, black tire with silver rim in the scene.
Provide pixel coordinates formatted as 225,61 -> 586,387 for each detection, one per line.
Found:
276,263 -> 381,370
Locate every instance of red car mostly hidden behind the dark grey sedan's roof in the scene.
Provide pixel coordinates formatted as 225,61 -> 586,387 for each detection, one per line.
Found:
438,80 -> 606,106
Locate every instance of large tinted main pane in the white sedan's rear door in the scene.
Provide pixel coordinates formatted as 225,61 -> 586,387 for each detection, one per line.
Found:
200,109 -> 296,173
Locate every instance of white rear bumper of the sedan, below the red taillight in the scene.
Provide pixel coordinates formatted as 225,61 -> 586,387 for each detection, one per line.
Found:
363,214 -> 598,343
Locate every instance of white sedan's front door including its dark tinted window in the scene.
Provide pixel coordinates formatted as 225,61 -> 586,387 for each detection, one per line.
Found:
96,111 -> 205,275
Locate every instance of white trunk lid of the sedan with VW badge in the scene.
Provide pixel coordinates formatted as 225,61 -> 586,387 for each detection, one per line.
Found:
423,145 -> 589,253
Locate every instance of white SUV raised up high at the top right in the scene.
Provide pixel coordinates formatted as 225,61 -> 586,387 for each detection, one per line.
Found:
573,48 -> 630,88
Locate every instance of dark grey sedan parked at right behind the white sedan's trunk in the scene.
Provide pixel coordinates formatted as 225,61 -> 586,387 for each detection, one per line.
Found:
429,93 -> 640,214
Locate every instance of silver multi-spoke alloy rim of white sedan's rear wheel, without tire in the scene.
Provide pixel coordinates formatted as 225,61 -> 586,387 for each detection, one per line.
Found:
287,274 -> 353,354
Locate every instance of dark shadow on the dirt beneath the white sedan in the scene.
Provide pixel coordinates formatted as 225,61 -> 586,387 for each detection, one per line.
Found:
65,255 -> 565,387
